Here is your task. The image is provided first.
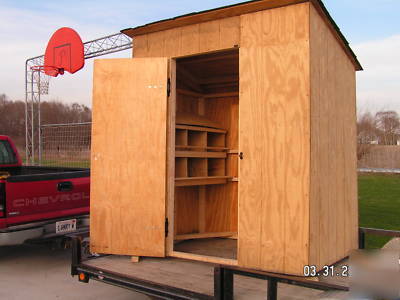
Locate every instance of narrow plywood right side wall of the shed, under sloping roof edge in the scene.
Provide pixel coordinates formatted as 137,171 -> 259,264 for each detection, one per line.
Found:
310,5 -> 358,266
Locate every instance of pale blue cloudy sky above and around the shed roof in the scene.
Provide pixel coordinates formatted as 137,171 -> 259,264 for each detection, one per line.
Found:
0,0 -> 400,113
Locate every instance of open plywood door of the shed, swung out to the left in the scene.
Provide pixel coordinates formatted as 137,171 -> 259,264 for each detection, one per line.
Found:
90,58 -> 168,257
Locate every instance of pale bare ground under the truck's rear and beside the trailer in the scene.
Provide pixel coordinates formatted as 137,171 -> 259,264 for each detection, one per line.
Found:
0,245 -> 149,300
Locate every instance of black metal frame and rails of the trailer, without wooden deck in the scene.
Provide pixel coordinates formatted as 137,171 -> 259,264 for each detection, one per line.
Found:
71,236 -> 349,300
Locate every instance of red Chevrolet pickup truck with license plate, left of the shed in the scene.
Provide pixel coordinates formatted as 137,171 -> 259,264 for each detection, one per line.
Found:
0,135 -> 90,246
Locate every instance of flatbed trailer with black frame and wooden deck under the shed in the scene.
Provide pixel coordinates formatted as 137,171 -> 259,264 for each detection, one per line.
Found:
71,236 -> 349,300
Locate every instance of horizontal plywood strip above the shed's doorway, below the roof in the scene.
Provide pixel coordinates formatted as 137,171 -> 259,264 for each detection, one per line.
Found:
133,17 -> 240,57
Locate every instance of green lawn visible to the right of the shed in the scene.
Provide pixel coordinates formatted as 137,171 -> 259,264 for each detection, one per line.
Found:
358,174 -> 400,248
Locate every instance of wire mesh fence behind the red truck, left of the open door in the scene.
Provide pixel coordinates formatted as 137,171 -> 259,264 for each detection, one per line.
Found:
39,122 -> 92,168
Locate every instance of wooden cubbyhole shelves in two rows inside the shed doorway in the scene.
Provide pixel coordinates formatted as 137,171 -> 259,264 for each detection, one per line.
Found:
175,124 -> 231,186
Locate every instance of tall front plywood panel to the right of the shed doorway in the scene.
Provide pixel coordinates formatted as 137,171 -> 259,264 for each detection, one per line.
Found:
238,3 -> 310,274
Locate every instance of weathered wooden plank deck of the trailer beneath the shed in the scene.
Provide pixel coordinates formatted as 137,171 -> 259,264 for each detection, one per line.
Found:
85,255 -> 323,300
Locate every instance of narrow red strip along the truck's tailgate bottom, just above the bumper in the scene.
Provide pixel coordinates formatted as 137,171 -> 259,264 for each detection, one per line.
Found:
0,207 -> 89,229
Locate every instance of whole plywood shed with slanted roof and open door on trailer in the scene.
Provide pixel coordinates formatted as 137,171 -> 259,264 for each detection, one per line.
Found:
90,0 -> 362,275
